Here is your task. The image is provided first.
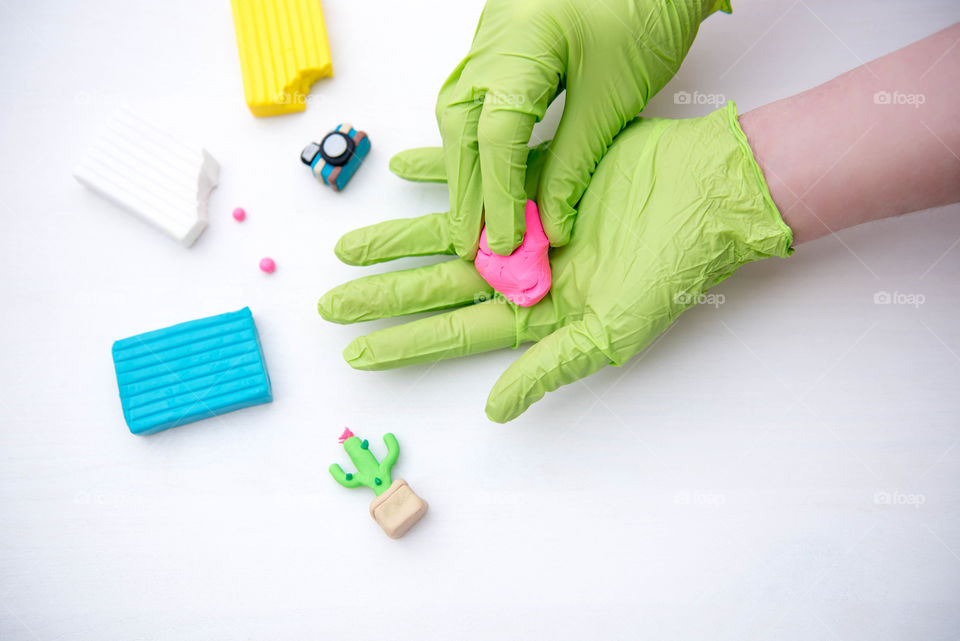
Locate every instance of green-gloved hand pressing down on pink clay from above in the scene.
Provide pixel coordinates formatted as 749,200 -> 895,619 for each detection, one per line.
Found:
408,0 -> 730,258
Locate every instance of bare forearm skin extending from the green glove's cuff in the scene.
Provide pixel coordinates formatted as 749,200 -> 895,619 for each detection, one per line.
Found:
740,23 -> 960,244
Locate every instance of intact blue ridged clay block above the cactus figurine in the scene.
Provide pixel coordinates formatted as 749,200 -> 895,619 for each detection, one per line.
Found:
113,307 -> 273,435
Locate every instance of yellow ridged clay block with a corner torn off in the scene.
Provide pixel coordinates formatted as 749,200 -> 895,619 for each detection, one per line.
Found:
231,0 -> 333,116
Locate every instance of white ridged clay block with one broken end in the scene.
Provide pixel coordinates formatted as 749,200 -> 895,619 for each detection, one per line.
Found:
73,109 -> 220,247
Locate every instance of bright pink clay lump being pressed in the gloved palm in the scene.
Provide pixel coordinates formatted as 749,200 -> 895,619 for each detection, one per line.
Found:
474,200 -> 550,307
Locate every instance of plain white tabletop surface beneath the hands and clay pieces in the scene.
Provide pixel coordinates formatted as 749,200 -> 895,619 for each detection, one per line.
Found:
0,0 -> 960,641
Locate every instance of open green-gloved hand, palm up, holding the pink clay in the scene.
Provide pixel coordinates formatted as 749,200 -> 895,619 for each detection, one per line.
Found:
318,103 -> 792,422
